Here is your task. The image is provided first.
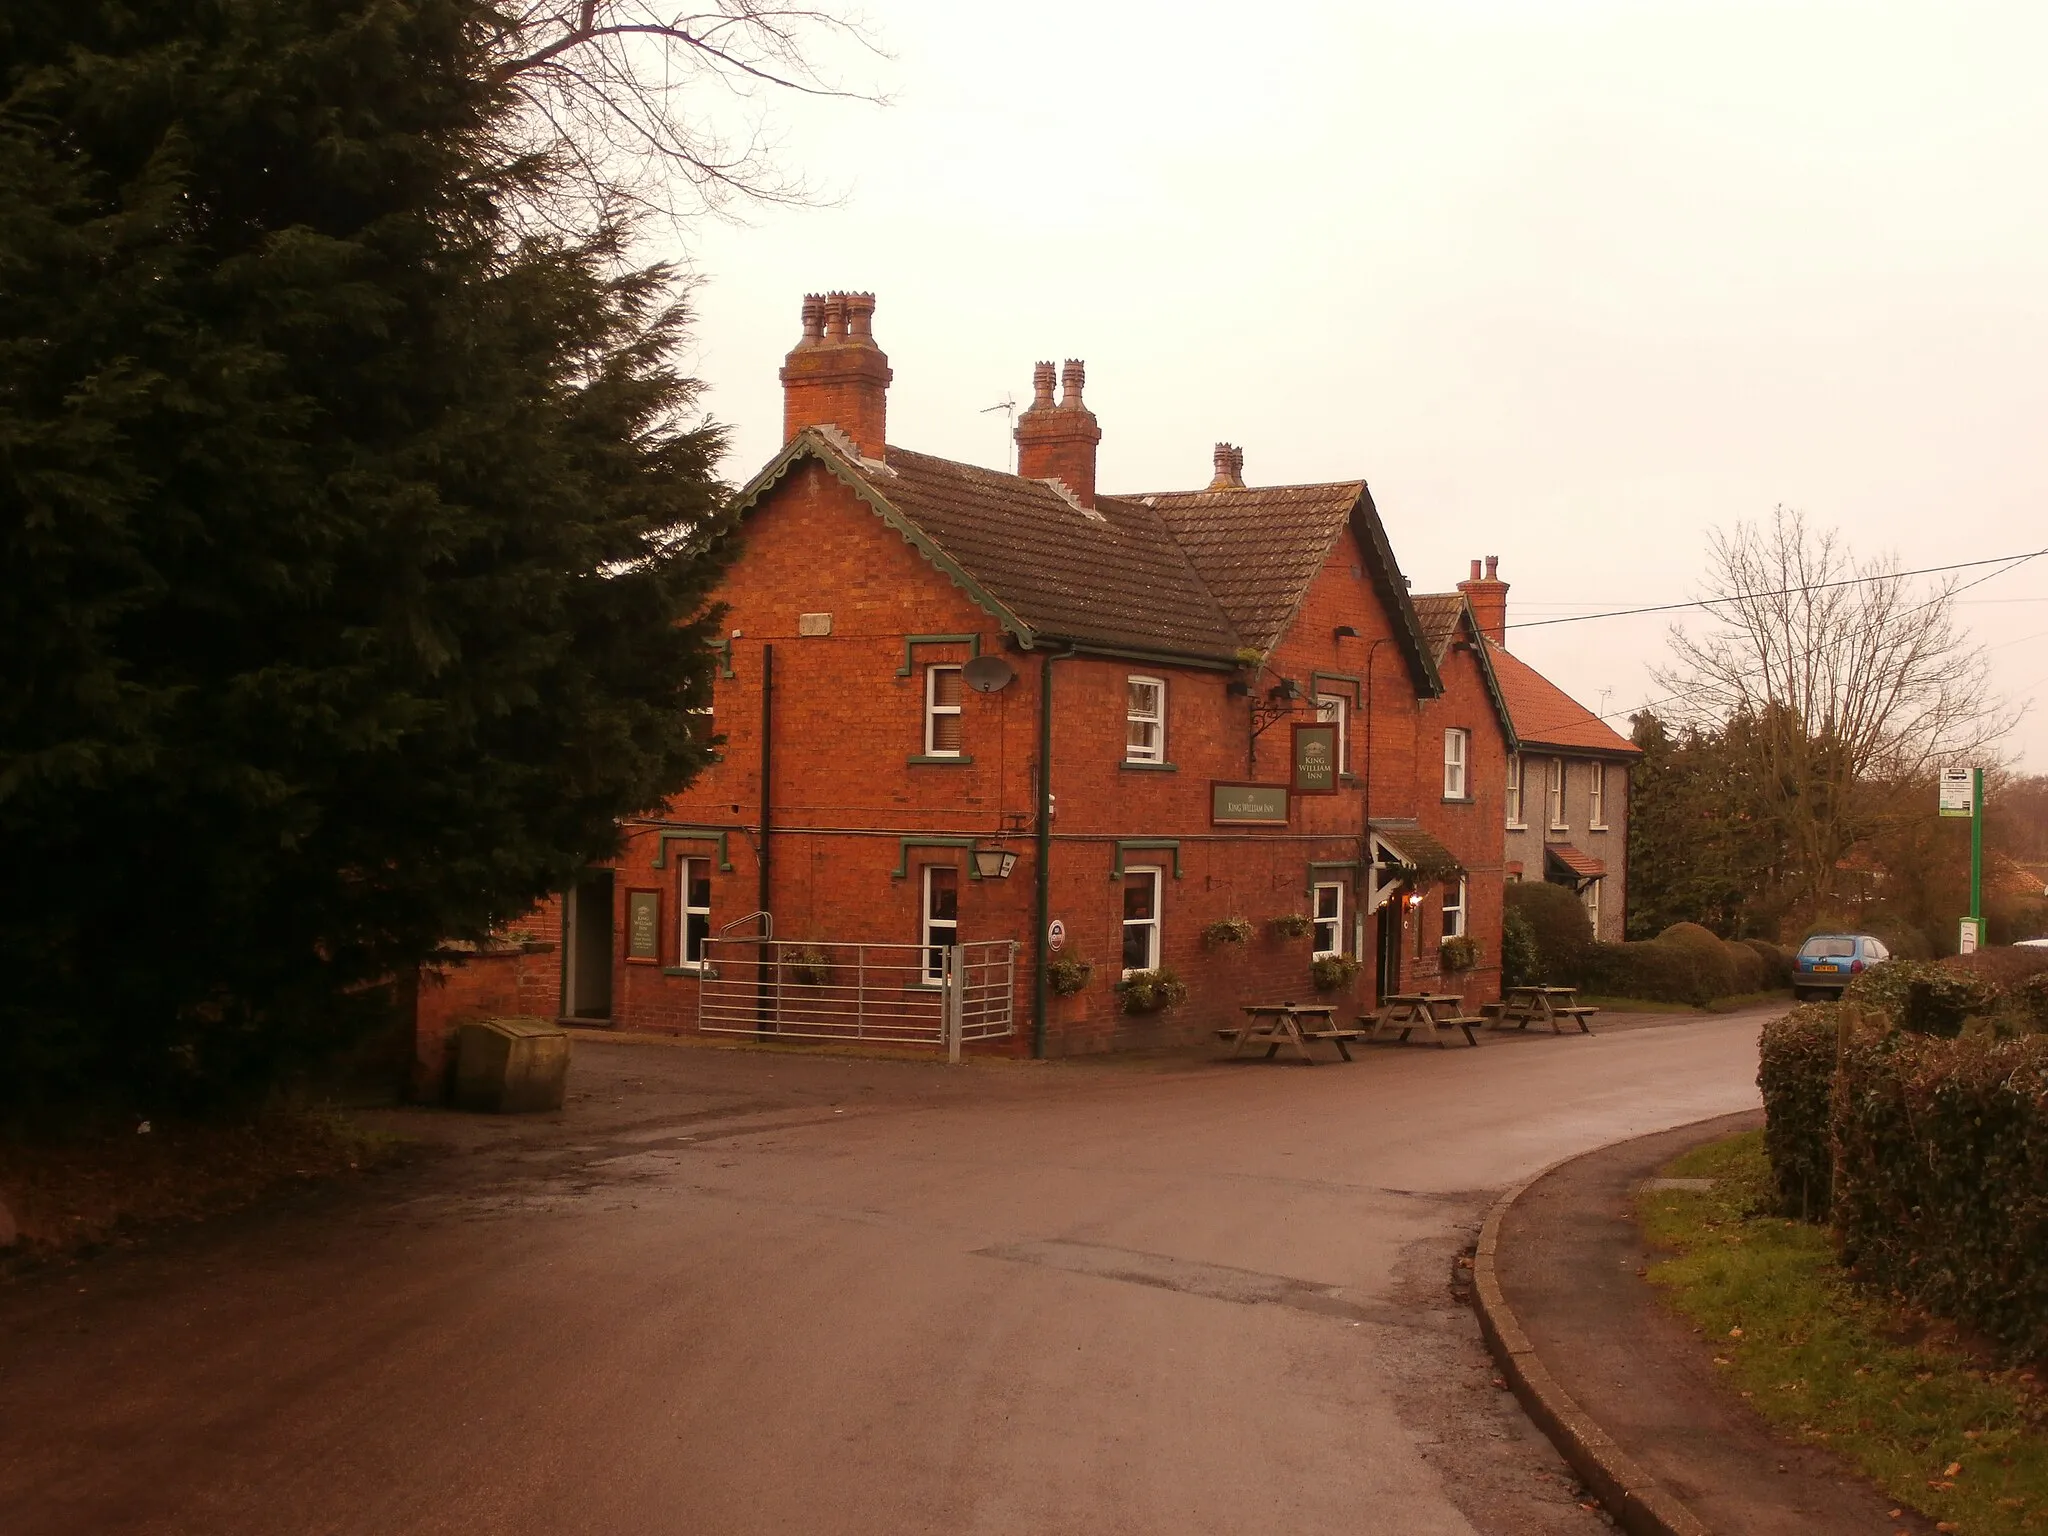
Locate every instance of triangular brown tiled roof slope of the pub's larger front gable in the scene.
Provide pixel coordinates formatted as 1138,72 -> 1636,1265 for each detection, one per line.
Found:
1128,479 -> 1366,651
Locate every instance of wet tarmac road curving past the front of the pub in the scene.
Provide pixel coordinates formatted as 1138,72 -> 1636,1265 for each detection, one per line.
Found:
0,1014 -> 1763,1536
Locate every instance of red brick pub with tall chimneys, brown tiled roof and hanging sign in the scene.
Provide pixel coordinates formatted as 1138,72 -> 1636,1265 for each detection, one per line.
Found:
493,295 -> 1513,1055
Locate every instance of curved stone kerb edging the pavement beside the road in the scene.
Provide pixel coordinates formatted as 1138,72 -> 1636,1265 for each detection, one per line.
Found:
1473,1126 -> 1714,1536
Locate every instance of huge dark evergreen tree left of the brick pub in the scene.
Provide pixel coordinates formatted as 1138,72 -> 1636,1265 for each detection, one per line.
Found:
0,0 -> 719,1102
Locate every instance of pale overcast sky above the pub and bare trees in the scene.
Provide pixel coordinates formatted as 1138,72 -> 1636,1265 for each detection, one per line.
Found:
663,0 -> 2048,772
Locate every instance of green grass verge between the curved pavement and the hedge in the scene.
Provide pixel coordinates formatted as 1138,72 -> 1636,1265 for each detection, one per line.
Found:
1636,1130 -> 2048,1536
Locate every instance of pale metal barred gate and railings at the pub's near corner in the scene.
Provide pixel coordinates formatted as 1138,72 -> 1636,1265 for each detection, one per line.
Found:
696,913 -> 1018,1061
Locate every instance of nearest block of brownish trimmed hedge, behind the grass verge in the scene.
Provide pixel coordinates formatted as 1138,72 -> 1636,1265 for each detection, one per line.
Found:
1831,1032 -> 2048,1360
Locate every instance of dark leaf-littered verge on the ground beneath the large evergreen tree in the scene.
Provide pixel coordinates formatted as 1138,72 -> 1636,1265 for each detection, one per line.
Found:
0,1110 -> 403,1264
